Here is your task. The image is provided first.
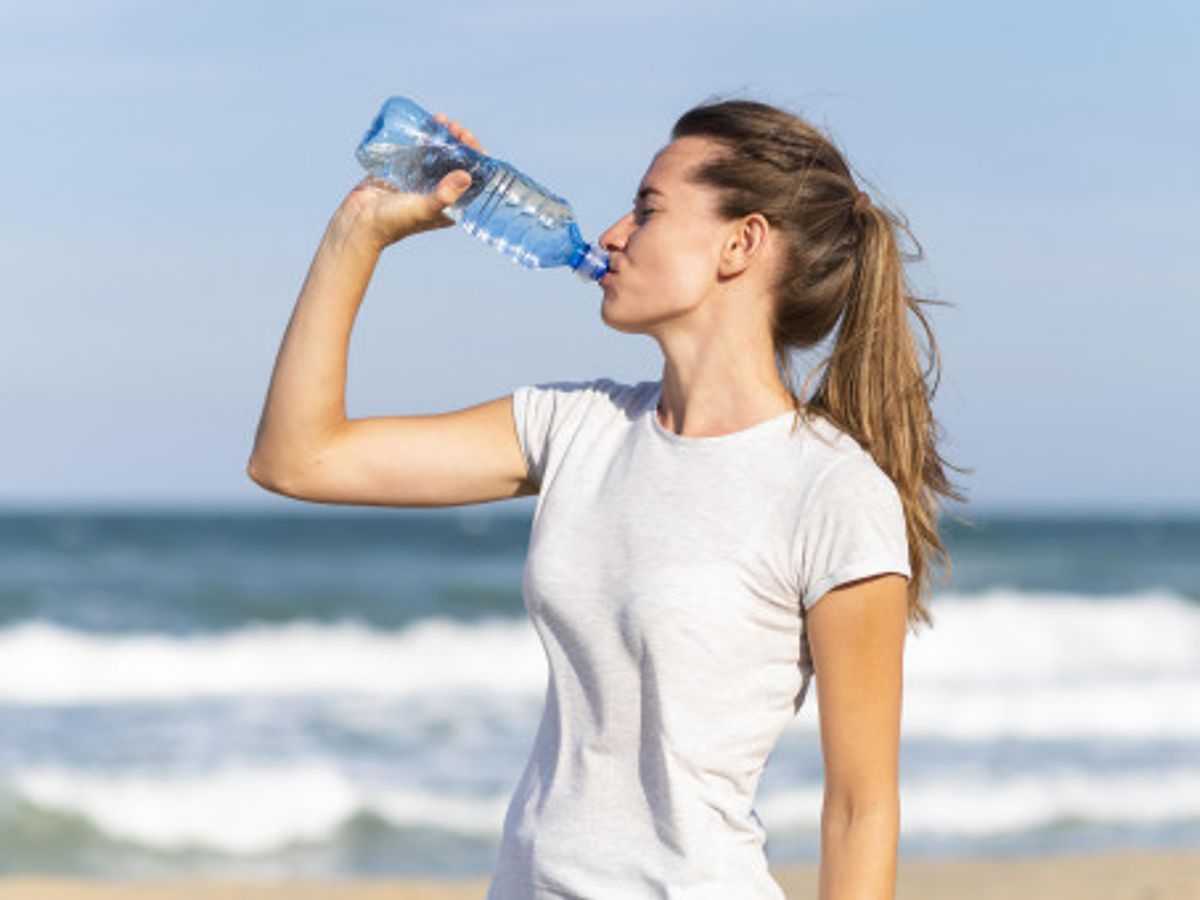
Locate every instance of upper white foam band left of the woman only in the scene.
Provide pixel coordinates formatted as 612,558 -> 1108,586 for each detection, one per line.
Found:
0,619 -> 545,704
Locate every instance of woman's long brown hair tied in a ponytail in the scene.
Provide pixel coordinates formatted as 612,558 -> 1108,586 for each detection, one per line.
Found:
672,100 -> 966,625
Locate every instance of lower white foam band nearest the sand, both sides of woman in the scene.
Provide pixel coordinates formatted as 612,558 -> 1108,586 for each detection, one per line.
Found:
10,762 -> 1200,854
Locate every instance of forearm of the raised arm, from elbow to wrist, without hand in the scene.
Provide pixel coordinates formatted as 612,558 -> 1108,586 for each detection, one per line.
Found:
251,209 -> 379,475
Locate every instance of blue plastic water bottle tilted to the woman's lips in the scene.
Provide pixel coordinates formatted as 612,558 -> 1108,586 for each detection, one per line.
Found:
356,97 -> 608,281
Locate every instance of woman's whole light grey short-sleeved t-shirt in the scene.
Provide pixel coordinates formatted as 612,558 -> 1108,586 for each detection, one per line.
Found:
487,379 -> 911,900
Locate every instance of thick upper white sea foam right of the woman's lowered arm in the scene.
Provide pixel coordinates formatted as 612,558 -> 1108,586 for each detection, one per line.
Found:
904,590 -> 1200,739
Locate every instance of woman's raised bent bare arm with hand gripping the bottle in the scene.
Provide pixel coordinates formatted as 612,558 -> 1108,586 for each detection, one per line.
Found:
246,124 -> 535,506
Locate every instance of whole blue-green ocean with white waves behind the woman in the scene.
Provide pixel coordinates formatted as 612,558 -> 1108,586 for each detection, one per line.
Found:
0,503 -> 1200,878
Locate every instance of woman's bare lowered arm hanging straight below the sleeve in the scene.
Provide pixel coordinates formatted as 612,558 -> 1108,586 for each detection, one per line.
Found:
806,575 -> 907,900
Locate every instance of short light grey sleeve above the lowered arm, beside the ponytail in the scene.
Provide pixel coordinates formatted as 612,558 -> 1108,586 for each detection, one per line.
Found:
796,457 -> 912,611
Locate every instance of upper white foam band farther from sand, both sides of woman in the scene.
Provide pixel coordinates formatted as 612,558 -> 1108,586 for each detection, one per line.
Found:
0,590 -> 1200,740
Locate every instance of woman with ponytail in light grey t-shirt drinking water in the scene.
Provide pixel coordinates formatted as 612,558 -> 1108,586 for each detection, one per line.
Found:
248,101 -> 959,900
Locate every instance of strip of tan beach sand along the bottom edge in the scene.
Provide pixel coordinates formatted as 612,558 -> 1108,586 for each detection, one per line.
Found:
0,848 -> 1200,900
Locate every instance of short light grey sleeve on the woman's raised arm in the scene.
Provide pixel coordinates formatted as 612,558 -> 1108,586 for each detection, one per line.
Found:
512,378 -> 611,487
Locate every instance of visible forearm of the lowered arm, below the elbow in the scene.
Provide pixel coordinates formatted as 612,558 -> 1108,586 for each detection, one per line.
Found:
818,804 -> 900,900
